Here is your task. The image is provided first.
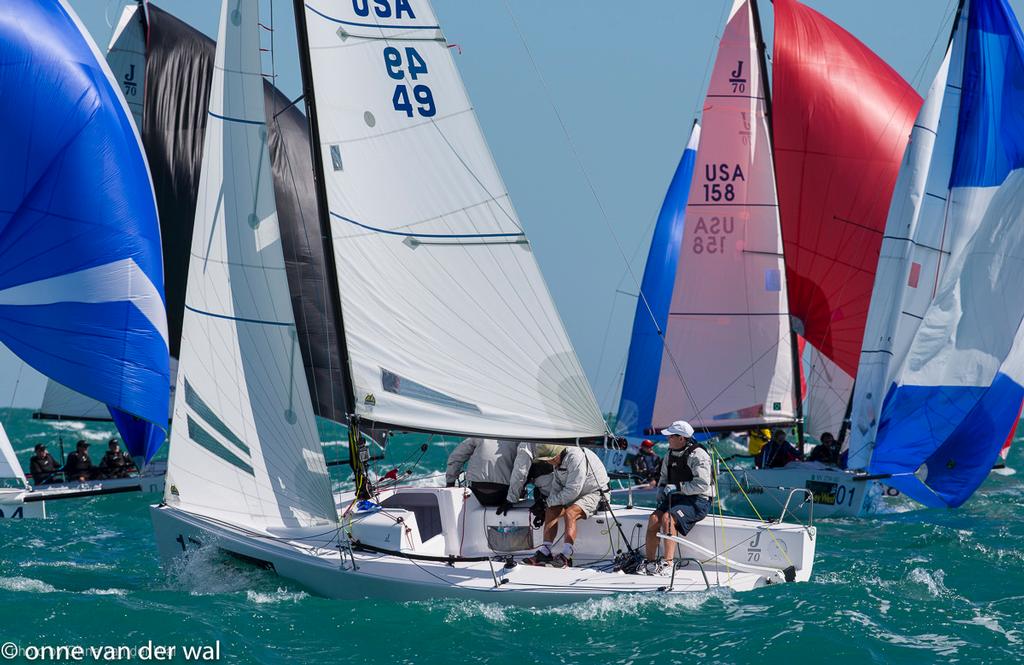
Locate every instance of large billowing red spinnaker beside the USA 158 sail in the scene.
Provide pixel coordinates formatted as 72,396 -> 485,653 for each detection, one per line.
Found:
772,0 -> 922,376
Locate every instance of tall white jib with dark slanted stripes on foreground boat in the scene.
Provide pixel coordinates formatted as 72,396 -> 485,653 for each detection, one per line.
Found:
165,0 -> 337,527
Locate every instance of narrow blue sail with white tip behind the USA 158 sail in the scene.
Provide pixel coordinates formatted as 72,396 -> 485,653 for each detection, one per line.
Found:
615,123 -> 700,437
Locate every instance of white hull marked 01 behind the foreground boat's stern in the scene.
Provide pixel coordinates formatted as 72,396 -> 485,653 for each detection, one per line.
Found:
718,462 -> 892,521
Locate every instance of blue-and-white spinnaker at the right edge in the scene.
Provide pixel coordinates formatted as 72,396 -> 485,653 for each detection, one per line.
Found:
869,0 -> 1024,507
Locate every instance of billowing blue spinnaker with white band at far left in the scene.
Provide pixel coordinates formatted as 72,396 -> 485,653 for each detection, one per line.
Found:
0,0 -> 168,455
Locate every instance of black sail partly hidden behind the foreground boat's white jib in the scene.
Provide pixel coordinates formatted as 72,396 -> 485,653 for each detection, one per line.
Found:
136,4 -> 347,422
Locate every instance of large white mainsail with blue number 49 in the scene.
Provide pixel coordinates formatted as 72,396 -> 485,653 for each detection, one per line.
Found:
296,0 -> 605,439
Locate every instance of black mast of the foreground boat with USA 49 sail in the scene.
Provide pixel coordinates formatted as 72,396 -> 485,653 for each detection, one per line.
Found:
293,0 -> 370,487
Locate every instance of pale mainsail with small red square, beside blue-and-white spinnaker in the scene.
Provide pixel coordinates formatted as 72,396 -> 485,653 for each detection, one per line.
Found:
844,16 -> 958,468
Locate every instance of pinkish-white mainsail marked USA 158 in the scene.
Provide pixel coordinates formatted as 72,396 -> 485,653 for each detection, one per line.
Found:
652,0 -> 796,428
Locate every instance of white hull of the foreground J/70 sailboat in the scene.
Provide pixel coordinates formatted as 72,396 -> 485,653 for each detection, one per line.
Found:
151,481 -> 815,606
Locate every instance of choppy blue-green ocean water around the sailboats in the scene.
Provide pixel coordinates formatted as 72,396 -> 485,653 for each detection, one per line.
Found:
0,403 -> 1024,665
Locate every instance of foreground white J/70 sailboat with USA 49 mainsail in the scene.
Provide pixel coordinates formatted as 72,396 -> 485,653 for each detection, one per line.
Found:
152,0 -> 815,605
